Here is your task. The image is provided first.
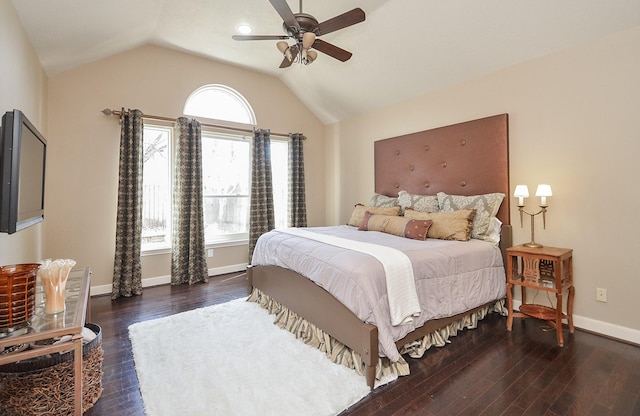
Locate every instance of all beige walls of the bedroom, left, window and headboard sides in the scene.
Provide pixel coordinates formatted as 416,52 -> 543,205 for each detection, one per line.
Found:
0,0 -> 640,342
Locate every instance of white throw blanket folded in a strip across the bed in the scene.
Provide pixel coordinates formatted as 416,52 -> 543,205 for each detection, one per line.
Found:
274,228 -> 420,326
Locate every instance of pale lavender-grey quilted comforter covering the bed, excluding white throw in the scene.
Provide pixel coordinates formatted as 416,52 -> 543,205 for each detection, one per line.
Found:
252,225 -> 506,361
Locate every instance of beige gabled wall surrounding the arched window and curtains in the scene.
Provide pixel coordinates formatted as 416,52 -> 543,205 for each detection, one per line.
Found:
45,46 -> 325,289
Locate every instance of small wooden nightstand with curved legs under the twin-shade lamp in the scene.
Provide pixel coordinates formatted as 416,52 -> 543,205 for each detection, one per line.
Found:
506,245 -> 575,347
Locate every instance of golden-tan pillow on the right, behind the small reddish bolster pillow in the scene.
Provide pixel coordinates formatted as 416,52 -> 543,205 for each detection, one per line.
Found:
404,209 -> 476,241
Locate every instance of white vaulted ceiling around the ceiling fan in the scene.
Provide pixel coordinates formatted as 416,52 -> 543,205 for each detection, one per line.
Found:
12,0 -> 640,123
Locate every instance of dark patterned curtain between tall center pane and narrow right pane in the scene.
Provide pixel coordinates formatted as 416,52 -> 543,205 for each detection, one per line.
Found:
249,129 -> 275,262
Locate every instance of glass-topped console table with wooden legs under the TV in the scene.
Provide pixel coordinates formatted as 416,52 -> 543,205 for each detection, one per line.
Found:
0,267 -> 91,416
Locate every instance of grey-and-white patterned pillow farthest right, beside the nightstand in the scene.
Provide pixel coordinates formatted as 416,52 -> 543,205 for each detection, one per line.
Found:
438,192 -> 504,240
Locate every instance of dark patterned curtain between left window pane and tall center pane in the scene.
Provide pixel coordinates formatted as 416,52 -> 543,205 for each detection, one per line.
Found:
171,117 -> 209,285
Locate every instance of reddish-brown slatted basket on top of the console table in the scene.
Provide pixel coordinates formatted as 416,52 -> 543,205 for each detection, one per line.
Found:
0,263 -> 40,332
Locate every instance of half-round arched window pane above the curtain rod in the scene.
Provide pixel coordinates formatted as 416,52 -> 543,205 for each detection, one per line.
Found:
184,84 -> 256,125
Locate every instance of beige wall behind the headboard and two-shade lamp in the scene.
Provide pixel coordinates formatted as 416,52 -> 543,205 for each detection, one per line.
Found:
327,27 -> 640,342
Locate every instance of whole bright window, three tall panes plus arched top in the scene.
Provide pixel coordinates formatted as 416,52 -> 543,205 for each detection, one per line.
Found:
142,85 -> 289,252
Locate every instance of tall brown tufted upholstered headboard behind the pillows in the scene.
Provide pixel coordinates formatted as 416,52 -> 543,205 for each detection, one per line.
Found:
374,114 -> 511,224
